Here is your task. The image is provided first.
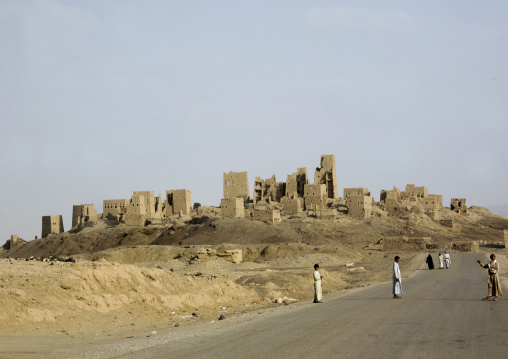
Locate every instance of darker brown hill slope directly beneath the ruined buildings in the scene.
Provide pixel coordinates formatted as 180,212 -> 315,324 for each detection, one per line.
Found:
0,207 -> 508,259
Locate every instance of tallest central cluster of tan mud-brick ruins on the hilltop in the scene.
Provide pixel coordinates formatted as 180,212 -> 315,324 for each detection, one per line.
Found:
221,155 -> 350,222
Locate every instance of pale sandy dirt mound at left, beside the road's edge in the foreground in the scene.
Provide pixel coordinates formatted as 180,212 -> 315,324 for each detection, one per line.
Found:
0,259 -> 258,335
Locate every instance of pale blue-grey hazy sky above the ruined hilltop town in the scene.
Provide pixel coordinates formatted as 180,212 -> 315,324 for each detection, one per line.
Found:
0,0 -> 508,245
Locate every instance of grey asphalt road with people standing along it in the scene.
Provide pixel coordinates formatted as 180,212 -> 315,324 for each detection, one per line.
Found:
122,253 -> 508,359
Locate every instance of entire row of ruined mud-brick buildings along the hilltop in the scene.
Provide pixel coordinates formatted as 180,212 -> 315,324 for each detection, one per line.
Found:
36,155 -> 467,237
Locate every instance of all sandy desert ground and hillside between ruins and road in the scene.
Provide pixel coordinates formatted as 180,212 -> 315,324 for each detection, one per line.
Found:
0,208 -> 508,357
